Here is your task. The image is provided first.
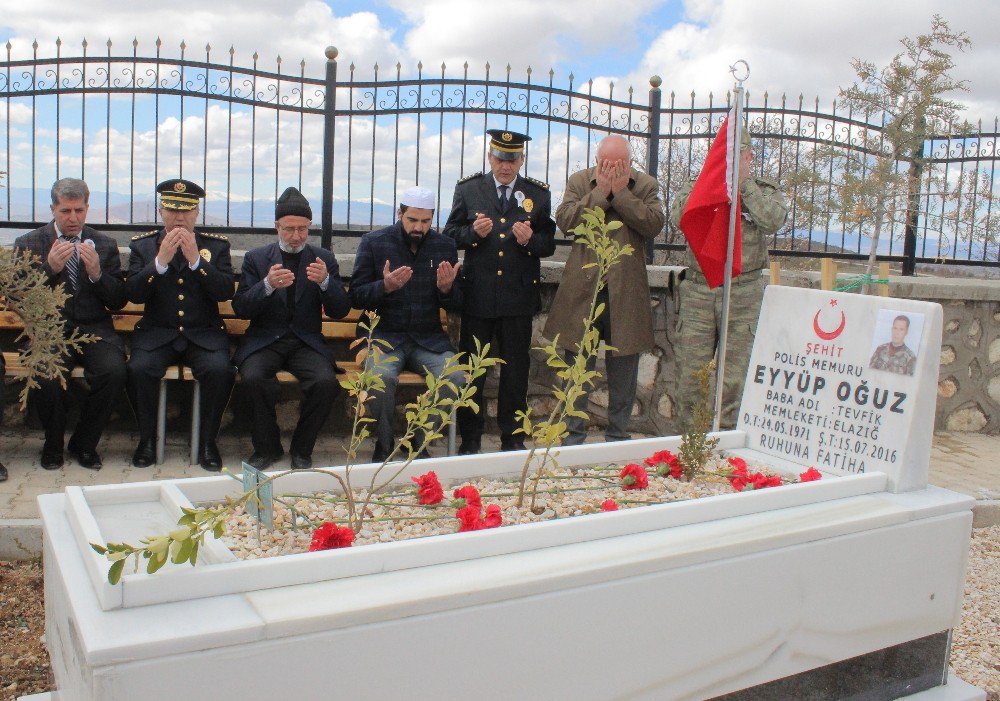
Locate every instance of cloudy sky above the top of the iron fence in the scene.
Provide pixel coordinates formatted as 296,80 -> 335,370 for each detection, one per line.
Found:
0,0 -> 1000,118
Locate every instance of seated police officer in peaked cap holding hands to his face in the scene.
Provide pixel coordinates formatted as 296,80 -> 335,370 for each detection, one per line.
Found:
125,178 -> 236,472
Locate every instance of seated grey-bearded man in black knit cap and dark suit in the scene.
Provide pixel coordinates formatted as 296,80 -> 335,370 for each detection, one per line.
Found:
233,187 -> 351,470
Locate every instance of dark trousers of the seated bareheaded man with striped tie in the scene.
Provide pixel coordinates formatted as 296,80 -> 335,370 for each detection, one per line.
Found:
34,341 -> 126,453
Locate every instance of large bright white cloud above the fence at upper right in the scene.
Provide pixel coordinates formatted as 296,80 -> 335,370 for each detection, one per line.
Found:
626,0 -> 1000,122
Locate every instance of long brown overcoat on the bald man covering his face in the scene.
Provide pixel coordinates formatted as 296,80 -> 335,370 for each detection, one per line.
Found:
544,168 -> 665,355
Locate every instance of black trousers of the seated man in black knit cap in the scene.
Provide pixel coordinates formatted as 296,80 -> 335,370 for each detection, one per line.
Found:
240,335 -> 340,456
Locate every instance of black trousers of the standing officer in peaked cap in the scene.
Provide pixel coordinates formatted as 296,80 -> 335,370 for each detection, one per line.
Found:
458,316 -> 531,443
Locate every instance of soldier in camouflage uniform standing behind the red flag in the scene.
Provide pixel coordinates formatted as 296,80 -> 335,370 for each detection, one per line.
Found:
670,131 -> 788,430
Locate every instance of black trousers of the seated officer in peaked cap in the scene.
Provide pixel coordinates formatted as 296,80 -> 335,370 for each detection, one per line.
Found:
128,338 -> 236,447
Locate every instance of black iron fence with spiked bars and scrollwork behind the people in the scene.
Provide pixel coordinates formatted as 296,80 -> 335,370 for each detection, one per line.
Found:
0,41 -> 1000,269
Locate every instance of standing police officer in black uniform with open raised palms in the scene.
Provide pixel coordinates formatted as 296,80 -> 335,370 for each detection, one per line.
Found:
444,129 -> 556,455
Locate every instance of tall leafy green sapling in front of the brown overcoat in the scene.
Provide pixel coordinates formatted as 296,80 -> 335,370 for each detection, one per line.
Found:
516,207 -> 634,508
